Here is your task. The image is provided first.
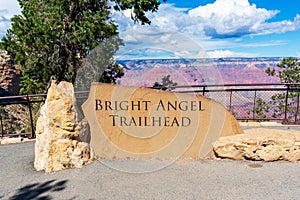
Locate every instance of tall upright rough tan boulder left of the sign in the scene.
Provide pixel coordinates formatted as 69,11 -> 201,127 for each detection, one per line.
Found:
34,81 -> 90,172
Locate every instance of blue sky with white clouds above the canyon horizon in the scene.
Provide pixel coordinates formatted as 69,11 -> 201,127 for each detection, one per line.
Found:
0,0 -> 300,59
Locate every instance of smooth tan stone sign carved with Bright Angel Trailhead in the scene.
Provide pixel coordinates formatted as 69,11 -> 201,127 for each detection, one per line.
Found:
82,83 -> 242,158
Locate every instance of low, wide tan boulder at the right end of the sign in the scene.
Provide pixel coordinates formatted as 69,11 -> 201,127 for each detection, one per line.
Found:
213,128 -> 300,162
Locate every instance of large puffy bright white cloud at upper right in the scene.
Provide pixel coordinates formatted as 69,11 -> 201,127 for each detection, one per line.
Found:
188,0 -> 300,38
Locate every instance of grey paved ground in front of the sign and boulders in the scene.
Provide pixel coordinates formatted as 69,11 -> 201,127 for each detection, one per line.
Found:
0,142 -> 300,200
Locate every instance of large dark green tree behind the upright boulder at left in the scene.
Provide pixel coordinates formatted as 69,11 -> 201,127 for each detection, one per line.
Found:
0,0 -> 165,93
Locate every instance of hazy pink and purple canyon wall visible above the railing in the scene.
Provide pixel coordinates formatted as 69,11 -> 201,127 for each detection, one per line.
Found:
118,57 -> 281,87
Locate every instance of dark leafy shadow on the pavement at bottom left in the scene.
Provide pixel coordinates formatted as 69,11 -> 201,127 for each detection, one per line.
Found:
10,180 -> 68,200
